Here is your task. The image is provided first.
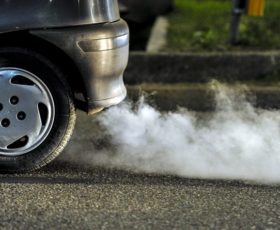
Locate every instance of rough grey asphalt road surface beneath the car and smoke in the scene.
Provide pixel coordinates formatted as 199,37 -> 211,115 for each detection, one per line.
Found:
0,110 -> 280,229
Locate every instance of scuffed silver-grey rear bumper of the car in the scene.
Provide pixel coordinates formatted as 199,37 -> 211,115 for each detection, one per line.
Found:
30,20 -> 129,113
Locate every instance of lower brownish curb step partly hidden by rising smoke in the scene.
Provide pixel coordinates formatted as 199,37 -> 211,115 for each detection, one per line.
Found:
127,83 -> 280,112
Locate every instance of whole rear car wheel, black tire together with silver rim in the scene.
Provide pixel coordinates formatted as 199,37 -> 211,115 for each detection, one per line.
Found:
0,48 -> 76,173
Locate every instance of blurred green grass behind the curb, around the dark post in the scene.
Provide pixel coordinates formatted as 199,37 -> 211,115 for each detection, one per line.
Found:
165,0 -> 280,51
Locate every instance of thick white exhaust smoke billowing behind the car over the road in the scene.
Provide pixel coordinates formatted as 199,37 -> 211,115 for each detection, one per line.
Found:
68,82 -> 280,183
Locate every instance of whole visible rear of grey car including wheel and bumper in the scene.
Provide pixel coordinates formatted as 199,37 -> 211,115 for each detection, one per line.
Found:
0,0 -> 129,173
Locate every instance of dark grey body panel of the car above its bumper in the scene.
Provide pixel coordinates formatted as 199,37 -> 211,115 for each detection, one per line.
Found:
0,0 -> 120,33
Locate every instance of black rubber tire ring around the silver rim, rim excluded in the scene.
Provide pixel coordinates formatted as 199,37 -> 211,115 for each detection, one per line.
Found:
0,48 -> 73,172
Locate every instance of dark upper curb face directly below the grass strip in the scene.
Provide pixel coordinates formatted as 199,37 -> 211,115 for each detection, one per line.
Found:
124,52 -> 280,84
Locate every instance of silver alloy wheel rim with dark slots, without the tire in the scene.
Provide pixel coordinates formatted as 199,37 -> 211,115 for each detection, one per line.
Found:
0,68 -> 55,156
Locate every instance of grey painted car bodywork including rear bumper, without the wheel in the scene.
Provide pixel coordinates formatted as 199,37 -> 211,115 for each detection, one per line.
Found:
0,0 -> 129,113
